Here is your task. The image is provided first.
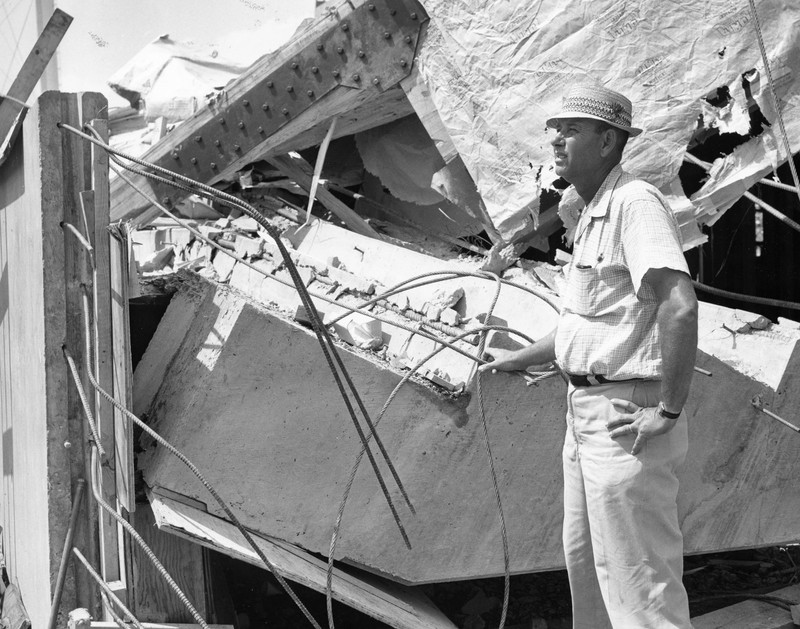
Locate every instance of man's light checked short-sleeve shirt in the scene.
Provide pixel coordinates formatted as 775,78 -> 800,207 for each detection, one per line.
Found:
555,166 -> 689,380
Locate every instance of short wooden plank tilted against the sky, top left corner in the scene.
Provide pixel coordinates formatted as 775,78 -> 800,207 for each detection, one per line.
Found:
0,9 -> 72,164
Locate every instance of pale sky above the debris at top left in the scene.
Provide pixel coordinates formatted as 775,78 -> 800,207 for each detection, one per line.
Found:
0,0 -> 315,106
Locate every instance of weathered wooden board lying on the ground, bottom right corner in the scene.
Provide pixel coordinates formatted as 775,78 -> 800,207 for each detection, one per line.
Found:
692,584 -> 800,629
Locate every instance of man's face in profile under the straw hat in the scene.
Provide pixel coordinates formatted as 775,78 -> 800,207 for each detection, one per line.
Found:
551,118 -> 603,184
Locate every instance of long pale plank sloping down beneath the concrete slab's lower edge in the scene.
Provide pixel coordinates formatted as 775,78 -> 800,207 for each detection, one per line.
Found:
151,494 -> 455,629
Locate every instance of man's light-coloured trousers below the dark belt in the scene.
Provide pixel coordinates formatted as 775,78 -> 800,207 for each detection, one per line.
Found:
563,381 -> 691,629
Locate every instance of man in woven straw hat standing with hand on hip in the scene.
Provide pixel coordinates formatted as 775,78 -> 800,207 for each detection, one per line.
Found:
480,86 -> 697,629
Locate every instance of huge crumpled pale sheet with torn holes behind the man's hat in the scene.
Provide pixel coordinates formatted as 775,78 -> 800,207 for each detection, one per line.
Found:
420,0 -> 800,238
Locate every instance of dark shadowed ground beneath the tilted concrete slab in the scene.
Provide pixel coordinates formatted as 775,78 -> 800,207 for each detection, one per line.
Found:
219,545 -> 800,629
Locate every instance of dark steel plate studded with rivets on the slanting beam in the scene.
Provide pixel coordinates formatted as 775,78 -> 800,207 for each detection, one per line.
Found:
152,0 -> 428,199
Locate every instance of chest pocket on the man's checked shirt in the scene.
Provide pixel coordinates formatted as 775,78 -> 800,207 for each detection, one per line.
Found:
564,264 -> 631,317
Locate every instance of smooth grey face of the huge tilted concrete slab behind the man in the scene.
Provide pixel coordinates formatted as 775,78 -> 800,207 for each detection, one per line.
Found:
136,280 -> 800,583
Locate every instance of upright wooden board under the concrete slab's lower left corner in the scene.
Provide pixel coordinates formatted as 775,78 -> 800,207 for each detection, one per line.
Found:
131,505 -> 206,623
